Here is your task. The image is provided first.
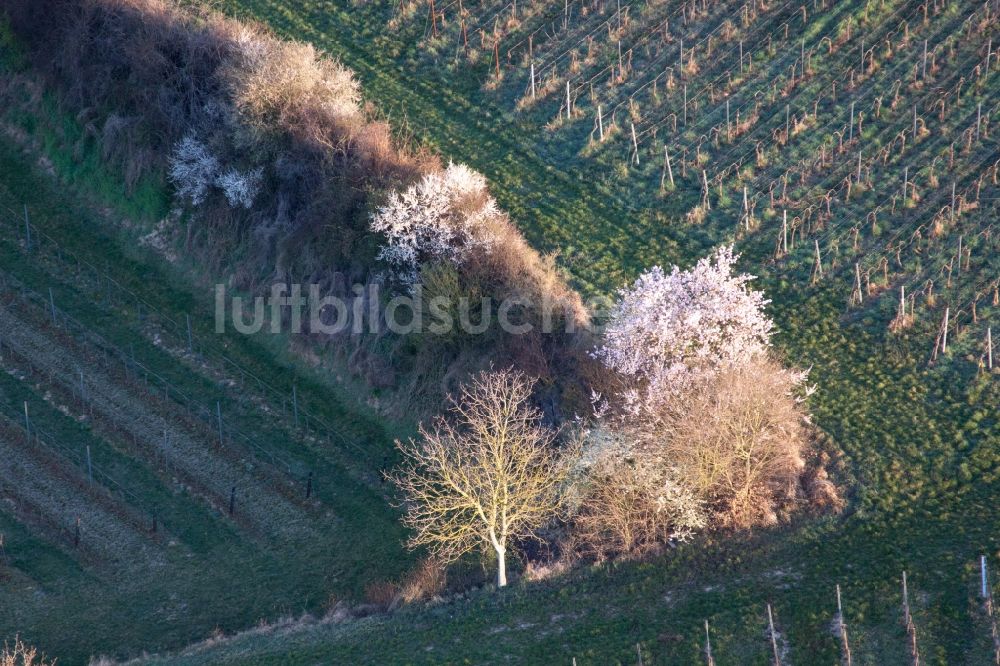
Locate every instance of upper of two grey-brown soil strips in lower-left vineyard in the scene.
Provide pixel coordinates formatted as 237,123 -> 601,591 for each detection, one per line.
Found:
0,300 -> 312,538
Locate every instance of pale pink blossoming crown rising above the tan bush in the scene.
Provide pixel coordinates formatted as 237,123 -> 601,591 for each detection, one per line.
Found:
596,246 -> 773,409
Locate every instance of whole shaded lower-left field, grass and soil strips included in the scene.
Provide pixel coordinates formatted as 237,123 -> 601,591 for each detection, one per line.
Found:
0,142 -> 411,664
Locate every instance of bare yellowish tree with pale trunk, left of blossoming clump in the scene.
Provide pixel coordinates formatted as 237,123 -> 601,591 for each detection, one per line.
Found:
390,370 -> 567,587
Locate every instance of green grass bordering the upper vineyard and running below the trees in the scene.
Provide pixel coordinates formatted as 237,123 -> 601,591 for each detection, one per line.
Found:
127,0 -> 1000,663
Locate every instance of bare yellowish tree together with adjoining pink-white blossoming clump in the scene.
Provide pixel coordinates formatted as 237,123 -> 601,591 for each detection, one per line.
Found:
391,247 -> 835,586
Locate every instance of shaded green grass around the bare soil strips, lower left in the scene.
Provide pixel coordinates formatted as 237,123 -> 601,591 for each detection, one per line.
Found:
0,130 -> 418,663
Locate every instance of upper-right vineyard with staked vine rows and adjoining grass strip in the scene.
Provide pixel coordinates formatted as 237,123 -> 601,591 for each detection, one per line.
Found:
215,1 -> 1000,363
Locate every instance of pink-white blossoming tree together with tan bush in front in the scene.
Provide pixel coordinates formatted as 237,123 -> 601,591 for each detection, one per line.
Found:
585,246 -> 810,528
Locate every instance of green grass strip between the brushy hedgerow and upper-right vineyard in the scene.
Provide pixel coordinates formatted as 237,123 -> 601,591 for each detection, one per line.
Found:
219,0 -> 708,291
